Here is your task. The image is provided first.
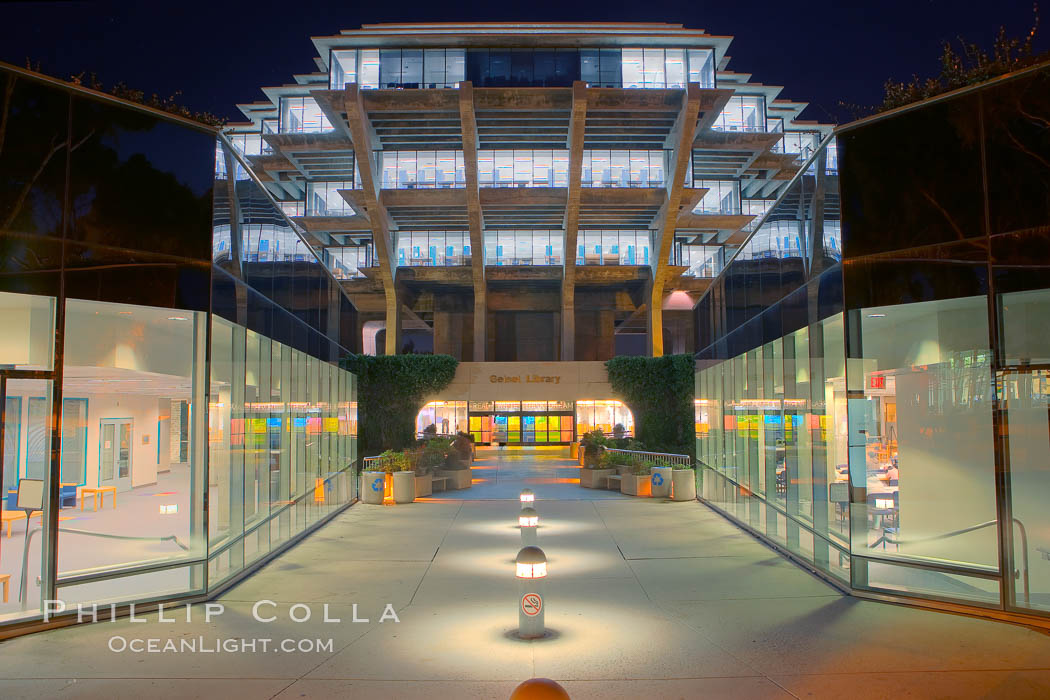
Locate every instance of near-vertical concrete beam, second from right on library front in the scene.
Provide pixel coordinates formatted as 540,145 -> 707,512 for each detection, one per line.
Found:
562,81 -> 588,362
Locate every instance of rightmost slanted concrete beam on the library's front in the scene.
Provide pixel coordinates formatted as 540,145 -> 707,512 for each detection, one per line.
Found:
649,83 -> 706,357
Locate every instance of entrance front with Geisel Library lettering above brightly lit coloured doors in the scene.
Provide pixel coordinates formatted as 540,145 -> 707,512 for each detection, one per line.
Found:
417,362 -> 633,445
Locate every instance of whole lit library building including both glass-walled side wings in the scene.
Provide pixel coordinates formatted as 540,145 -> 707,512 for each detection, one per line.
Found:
0,24 -> 1050,635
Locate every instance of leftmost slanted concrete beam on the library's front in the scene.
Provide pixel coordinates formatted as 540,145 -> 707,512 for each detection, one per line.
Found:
340,83 -> 401,355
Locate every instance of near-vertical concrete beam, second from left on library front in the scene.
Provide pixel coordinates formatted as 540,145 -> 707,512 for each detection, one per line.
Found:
459,81 -> 488,362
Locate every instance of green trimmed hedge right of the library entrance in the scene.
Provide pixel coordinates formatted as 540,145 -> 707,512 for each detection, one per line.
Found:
605,355 -> 696,458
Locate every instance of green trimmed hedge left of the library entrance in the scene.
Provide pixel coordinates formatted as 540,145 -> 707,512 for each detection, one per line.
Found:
342,355 -> 459,455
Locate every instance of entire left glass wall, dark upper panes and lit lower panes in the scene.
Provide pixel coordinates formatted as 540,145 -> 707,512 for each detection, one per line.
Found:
0,68 -> 357,624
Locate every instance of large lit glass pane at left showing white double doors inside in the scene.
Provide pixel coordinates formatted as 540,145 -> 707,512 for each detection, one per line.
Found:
58,299 -> 206,600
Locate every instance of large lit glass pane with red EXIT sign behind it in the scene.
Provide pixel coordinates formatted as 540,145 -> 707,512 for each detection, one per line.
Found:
848,297 -> 999,568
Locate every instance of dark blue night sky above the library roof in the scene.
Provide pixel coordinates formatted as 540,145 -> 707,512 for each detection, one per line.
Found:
0,0 -> 1050,122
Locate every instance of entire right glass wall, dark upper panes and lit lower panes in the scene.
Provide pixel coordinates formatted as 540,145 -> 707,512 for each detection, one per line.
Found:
696,67 -> 1050,615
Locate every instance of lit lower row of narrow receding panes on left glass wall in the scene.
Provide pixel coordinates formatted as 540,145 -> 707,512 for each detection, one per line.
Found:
208,317 -> 357,588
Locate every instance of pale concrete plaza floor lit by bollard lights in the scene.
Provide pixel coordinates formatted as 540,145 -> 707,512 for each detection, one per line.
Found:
0,458 -> 1050,700
